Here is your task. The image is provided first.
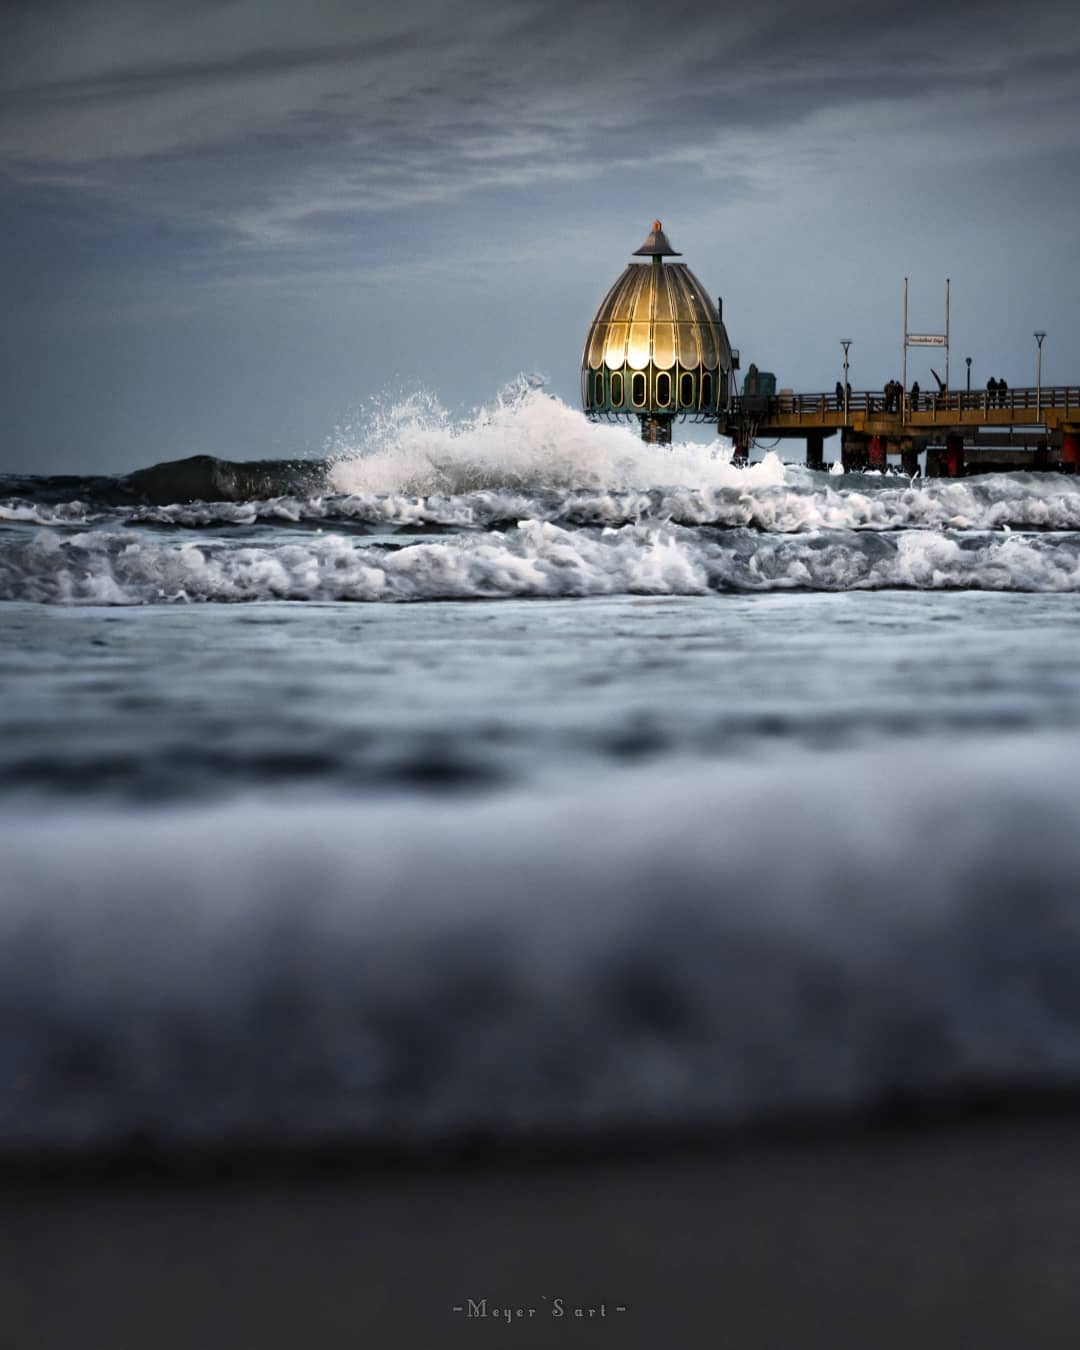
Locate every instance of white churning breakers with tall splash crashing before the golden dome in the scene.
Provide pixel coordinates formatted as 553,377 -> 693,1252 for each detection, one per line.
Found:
0,379 -> 1080,605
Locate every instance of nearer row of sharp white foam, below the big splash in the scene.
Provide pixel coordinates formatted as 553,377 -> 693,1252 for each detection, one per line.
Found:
0,520 -> 1080,605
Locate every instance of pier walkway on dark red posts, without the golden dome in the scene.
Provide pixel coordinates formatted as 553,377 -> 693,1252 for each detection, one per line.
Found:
720,385 -> 1080,478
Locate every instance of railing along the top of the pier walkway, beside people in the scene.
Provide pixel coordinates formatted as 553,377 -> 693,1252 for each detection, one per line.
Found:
733,385 -> 1080,423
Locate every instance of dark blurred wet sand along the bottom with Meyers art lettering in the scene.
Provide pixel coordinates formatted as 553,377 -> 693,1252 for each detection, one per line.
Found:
0,1116 -> 1080,1350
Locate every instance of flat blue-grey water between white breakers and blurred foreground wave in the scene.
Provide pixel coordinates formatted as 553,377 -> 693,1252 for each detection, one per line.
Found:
0,593 -> 1080,803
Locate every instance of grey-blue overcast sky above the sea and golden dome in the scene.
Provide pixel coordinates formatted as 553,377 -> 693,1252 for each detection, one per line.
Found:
0,0 -> 1080,473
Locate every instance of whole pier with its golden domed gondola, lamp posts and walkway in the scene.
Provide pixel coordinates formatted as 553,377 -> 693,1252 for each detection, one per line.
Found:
581,220 -> 1080,478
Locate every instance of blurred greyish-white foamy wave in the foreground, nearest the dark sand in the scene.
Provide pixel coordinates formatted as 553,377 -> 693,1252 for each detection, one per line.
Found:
0,736 -> 1080,1146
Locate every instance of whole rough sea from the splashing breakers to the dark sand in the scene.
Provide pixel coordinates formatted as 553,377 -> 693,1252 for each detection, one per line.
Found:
0,381 -> 1080,1158
